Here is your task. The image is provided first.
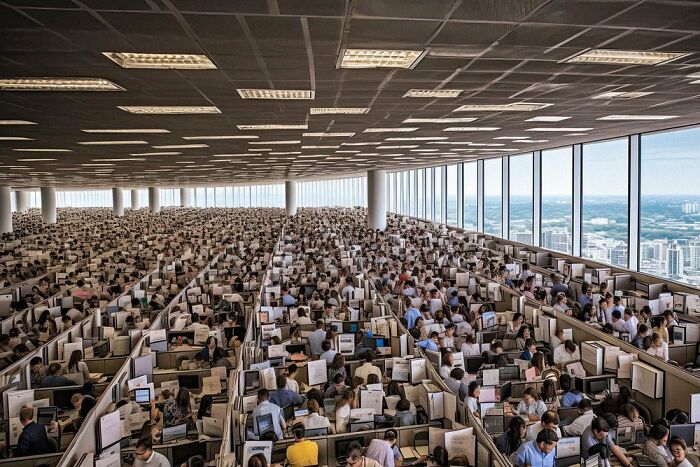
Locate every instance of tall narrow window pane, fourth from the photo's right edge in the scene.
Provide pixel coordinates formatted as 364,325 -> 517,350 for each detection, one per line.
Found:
508,153 -> 533,245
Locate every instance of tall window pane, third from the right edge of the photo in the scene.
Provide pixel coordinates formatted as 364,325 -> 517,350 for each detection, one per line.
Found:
540,146 -> 574,254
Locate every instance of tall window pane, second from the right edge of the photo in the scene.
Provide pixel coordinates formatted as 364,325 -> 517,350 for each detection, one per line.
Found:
581,138 -> 629,267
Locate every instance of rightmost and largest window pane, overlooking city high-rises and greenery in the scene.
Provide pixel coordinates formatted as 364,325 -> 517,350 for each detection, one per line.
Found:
639,127 -> 700,285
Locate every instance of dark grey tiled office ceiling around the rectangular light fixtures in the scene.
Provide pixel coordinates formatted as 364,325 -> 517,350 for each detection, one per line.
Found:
0,0 -> 700,187
